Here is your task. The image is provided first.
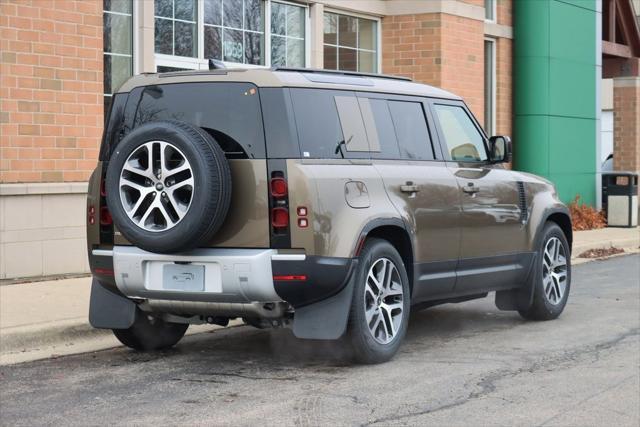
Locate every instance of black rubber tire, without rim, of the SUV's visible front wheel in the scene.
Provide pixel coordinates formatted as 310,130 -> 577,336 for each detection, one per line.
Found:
518,222 -> 571,320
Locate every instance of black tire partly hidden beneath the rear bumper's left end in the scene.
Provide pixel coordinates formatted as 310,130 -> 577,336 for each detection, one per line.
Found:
112,309 -> 189,351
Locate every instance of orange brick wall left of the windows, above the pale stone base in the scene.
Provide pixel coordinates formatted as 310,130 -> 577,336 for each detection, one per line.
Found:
0,0 -> 103,183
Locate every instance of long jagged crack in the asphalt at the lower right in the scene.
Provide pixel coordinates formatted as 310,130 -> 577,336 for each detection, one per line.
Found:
363,328 -> 640,426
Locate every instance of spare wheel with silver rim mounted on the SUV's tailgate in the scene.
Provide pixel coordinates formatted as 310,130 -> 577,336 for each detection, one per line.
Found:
105,121 -> 231,253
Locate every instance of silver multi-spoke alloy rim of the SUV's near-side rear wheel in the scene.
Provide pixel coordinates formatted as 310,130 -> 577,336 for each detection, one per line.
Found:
364,258 -> 404,344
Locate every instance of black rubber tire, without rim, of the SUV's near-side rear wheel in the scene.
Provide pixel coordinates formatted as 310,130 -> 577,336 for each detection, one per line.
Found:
345,238 -> 411,364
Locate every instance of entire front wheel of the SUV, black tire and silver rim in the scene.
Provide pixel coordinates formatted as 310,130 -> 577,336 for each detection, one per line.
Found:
518,222 -> 571,320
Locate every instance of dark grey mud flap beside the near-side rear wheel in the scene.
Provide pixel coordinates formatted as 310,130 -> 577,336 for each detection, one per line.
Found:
293,269 -> 355,340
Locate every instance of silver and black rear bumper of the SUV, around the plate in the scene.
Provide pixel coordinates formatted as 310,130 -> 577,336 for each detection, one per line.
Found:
90,246 -> 355,308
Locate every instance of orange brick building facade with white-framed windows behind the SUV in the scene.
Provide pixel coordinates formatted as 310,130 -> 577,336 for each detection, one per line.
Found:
0,0 -> 638,279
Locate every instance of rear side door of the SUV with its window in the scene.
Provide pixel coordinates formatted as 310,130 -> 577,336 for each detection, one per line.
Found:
358,93 -> 460,302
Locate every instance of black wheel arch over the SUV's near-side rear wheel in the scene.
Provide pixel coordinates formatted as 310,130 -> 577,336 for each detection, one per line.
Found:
354,218 -> 414,294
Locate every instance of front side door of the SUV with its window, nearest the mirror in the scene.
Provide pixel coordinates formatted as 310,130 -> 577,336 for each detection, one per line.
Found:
431,101 -> 527,292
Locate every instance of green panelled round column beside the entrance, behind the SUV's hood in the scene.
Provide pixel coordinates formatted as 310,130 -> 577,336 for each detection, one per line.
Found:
513,0 -> 599,205
